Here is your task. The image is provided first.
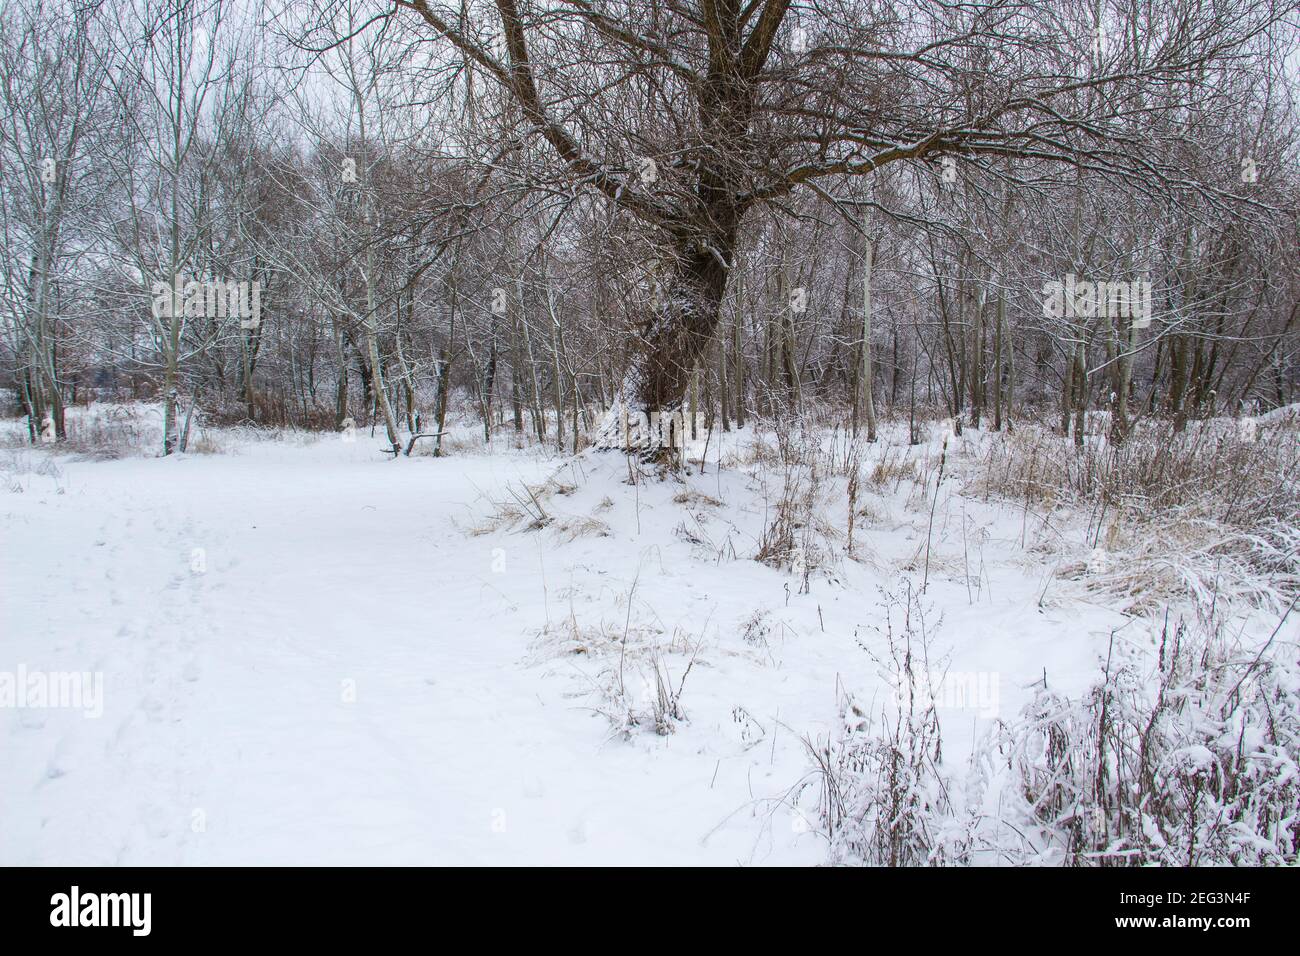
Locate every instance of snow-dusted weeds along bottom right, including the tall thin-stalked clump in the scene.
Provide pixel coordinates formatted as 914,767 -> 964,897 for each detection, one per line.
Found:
794,574 -> 1300,866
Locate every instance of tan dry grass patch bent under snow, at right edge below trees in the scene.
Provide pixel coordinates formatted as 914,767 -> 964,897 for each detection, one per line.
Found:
967,416 -> 1300,613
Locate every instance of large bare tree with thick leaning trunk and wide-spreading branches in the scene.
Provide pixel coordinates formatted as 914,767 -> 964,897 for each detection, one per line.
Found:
366,0 -> 1283,460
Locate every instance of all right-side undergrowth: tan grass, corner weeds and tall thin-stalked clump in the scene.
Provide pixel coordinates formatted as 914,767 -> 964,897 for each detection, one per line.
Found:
780,415 -> 1300,865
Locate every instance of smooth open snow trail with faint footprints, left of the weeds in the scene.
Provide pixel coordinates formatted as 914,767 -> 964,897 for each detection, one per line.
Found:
0,442 -> 821,865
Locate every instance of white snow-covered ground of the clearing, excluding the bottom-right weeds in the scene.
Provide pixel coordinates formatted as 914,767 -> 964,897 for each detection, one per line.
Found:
0,405 -> 1279,865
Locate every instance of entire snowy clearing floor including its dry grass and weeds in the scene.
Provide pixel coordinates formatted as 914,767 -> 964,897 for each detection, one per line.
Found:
0,408 -> 1300,865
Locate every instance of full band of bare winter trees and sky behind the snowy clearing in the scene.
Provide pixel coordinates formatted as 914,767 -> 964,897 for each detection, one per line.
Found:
0,0 -> 1300,454
